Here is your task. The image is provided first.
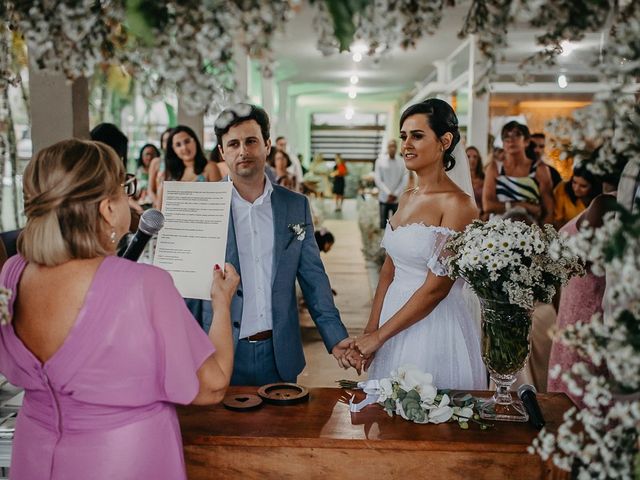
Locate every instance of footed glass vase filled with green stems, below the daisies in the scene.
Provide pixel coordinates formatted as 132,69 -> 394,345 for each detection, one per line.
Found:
480,298 -> 531,422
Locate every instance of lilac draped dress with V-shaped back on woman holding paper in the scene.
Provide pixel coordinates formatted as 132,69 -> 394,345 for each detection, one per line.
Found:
0,255 -> 214,480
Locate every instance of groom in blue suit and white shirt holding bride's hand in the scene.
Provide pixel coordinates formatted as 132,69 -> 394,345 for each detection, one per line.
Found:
188,104 -> 351,385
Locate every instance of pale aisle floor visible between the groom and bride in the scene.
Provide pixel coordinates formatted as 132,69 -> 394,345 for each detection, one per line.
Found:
298,200 -> 373,387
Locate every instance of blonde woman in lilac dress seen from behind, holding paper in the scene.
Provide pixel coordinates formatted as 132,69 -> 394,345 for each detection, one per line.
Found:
0,140 -> 239,480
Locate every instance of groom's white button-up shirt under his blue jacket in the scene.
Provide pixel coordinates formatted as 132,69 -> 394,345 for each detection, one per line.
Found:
231,177 -> 274,338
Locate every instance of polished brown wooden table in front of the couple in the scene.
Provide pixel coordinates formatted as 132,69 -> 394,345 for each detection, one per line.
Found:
178,387 -> 571,480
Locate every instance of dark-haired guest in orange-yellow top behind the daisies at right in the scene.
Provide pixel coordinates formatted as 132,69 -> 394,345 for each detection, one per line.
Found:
553,167 -> 602,230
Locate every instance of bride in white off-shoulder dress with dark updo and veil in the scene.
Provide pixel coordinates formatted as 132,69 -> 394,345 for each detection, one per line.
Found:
351,99 -> 487,389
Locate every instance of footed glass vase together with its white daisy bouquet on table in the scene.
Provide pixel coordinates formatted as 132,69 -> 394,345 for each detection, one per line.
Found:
444,218 -> 584,421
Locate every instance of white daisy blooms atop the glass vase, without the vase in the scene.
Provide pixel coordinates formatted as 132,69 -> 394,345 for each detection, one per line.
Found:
444,218 -> 584,310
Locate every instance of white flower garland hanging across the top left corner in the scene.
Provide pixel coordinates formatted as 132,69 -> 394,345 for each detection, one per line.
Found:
0,0 -> 292,114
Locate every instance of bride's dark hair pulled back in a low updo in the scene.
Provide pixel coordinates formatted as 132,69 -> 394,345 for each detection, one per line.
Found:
400,98 -> 460,172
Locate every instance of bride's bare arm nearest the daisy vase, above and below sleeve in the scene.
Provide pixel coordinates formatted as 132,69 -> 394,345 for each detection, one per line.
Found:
355,194 -> 478,356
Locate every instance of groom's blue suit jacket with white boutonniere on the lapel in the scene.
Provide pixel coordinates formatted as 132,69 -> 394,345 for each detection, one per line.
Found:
188,185 -> 348,380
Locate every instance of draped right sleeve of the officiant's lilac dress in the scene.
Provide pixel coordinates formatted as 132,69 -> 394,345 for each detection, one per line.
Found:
144,269 -> 215,405
